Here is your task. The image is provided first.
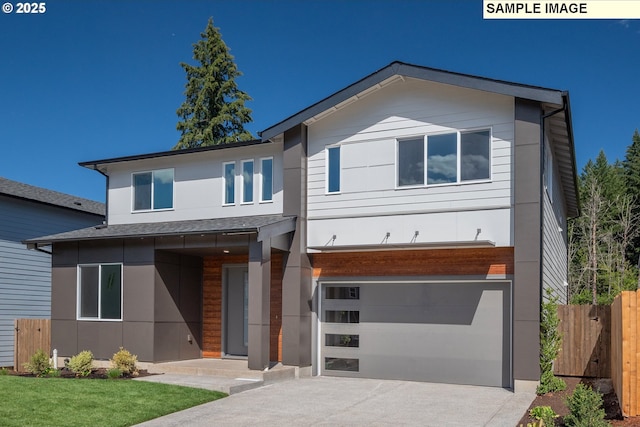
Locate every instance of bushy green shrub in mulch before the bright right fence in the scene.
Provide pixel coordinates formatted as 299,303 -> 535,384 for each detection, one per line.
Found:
564,384 -> 611,427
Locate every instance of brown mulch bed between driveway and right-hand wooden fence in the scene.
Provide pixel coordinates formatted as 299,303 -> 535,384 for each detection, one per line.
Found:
518,377 -> 624,427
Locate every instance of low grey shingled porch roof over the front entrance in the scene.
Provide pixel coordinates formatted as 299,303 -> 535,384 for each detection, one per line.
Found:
24,215 -> 296,245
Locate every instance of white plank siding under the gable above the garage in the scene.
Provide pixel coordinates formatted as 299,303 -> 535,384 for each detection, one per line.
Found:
308,78 -> 514,247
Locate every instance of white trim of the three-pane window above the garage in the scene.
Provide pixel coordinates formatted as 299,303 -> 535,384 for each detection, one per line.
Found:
395,127 -> 493,190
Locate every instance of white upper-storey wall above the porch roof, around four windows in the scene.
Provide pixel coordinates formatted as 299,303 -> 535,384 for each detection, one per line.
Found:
108,143 -> 282,224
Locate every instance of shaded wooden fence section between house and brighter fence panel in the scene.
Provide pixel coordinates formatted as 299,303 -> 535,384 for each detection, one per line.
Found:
554,305 -> 611,378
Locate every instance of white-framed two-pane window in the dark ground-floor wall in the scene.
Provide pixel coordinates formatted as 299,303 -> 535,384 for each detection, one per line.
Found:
78,264 -> 122,320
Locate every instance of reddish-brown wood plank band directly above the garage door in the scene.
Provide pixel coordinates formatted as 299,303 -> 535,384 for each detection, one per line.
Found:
311,247 -> 513,277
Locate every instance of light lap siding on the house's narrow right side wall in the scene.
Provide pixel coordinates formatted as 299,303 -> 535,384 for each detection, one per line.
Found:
542,149 -> 567,304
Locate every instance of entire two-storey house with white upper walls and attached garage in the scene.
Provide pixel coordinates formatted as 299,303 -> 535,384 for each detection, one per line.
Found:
30,62 -> 579,390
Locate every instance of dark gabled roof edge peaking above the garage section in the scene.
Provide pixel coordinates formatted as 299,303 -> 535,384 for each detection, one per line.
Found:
259,61 -> 565,141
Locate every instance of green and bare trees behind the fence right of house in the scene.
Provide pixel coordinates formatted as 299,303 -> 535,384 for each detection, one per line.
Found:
569,130 -> 640,304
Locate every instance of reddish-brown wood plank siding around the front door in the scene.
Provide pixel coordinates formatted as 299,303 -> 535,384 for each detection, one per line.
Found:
202,252 -> 282,361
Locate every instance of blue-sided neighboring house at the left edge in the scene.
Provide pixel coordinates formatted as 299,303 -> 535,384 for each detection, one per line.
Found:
0,177 -> 105,366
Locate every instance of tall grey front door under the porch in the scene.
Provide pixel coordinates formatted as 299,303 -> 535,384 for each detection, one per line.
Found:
225,267 -> 249,356
